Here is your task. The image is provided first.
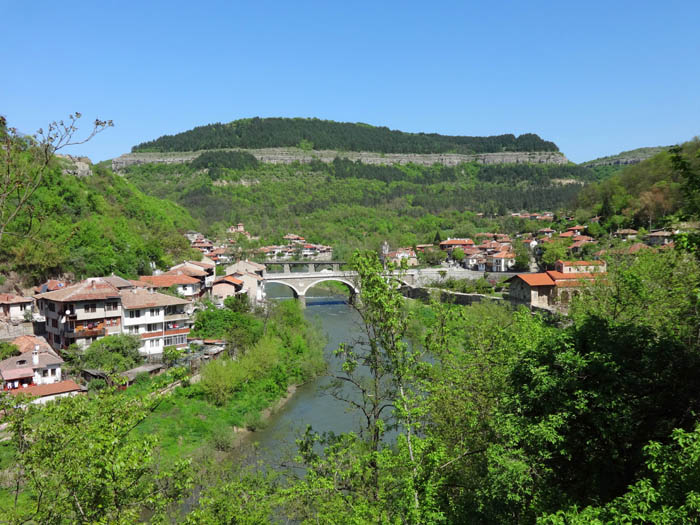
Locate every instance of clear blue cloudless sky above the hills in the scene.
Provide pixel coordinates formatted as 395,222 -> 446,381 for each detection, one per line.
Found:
0,0 -> 700,162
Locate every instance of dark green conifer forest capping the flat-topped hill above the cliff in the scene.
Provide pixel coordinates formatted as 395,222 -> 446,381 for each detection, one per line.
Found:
132,117 -> 559,154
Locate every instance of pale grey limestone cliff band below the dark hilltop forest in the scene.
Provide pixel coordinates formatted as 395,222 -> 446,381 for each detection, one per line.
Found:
112,148 -> 569,171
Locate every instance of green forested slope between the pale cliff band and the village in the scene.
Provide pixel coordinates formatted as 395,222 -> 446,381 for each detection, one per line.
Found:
125,154 -> 595,255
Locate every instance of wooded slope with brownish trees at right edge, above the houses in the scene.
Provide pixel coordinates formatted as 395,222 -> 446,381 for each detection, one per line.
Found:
577,139 -> 700,229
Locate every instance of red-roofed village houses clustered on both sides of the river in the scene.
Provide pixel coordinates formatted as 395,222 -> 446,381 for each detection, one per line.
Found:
0,212 -> 674,402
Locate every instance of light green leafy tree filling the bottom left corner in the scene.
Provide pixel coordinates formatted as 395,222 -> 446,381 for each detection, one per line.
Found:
0,389 -> 192,525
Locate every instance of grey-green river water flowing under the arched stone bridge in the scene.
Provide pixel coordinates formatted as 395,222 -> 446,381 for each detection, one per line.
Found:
243,283 -> 361,465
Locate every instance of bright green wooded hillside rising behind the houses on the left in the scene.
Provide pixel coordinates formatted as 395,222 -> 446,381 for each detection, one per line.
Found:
0,162 -> 196,282
